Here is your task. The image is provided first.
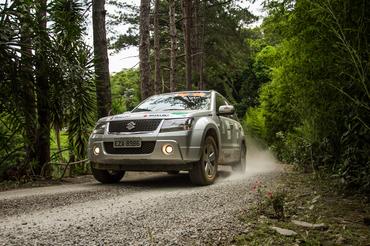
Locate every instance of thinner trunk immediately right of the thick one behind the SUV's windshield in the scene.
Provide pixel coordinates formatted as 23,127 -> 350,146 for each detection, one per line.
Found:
154,0 -> 163,94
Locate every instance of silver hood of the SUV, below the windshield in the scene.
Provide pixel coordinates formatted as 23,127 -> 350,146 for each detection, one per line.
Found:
105,110 -> 212,121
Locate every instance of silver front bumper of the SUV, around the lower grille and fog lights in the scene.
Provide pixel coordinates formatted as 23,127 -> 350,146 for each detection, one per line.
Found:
88,131 -> 201,171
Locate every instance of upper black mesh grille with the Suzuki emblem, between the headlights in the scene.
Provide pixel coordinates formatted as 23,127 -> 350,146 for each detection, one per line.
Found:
109,119 -> 161,132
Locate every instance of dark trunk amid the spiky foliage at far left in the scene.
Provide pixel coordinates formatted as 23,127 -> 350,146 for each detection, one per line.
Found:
35,0 -> 50,175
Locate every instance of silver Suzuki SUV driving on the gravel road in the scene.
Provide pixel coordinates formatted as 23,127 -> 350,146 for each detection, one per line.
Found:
88,91 -> 246,185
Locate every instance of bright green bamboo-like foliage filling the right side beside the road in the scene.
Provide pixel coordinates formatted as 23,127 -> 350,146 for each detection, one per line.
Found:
246,0 -> 370,190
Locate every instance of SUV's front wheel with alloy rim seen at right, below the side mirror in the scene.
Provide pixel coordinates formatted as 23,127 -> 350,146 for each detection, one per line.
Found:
189,136 -> 218,185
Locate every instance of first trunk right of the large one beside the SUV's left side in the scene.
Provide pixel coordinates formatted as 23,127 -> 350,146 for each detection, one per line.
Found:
139,0 -> 152,100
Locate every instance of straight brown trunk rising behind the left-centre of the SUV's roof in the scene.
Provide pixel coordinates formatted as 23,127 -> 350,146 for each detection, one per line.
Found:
182,0 -> 192,90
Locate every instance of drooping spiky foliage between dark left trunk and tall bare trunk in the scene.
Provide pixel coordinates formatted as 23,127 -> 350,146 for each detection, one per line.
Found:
50,0 -> 96,159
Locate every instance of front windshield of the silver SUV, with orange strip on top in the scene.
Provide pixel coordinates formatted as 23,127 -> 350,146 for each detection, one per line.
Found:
132,92 -> 211,112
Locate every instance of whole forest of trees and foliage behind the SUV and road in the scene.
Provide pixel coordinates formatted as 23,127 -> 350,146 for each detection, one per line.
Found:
0,0 -> 370,192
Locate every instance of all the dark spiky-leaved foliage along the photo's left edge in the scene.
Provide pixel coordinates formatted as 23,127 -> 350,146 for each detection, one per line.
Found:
0,0 -> 95,180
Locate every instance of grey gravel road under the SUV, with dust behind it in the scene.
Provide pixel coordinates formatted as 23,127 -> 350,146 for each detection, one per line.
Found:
0,147 -> 279,245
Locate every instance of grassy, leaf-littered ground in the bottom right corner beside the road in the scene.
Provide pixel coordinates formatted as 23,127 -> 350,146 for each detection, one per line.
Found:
233,167 -> 370,245
